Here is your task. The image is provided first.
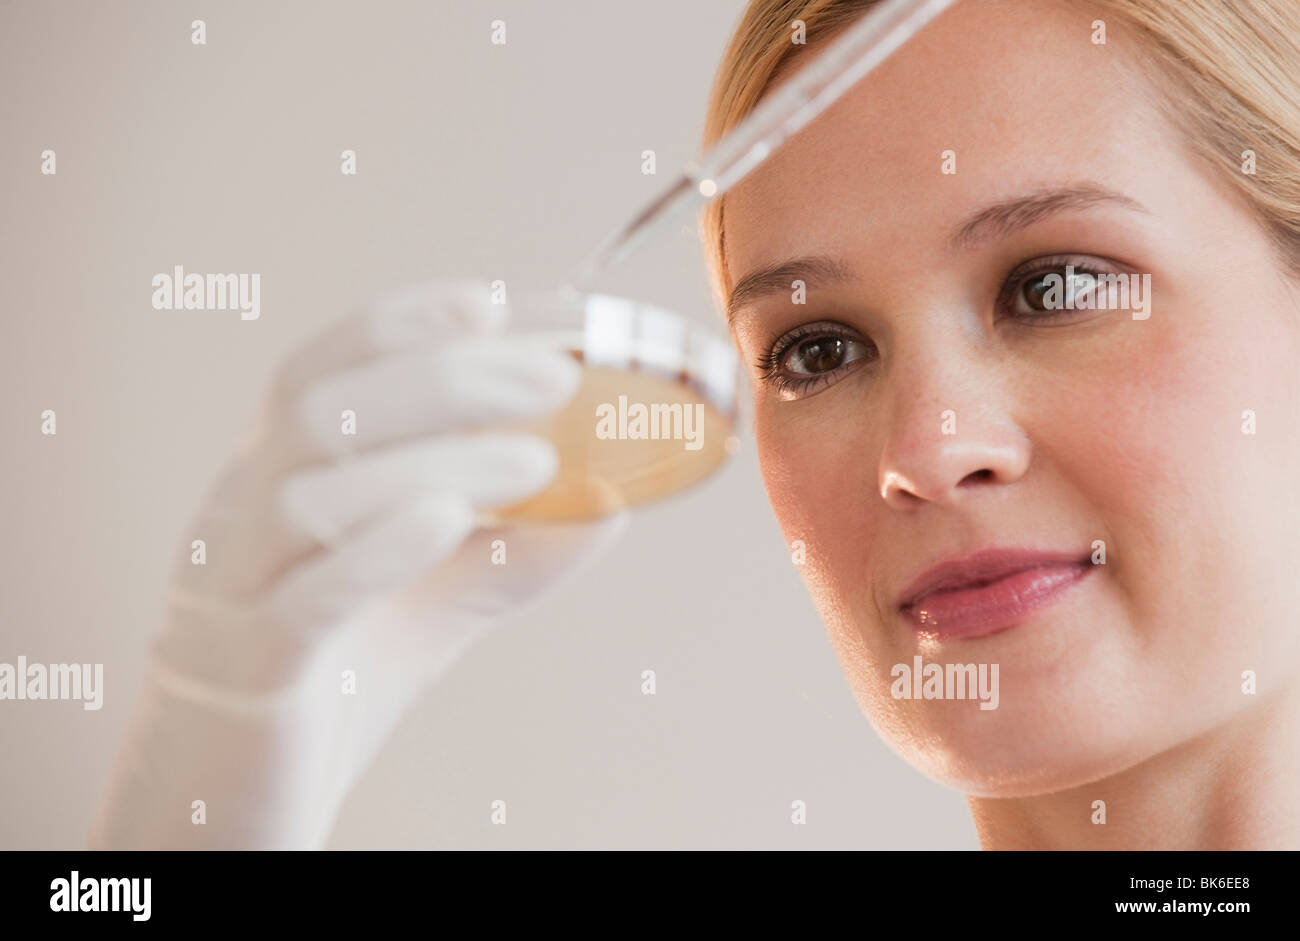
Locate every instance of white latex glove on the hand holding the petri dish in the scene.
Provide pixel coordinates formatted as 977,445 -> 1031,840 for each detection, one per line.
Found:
90,282 -> 627,849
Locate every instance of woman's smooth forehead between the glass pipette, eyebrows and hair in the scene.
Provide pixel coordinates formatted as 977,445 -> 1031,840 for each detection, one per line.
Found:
723,0 -> 1174,281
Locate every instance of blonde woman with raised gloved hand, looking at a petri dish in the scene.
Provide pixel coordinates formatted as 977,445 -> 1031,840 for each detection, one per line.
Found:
91,0 -> 1300,849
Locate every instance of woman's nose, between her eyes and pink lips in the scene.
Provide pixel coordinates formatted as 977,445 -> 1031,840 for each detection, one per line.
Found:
879,348 -> 1031,509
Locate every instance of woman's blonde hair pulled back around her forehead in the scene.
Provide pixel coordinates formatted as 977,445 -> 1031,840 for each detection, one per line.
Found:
699,0 -> 1300,304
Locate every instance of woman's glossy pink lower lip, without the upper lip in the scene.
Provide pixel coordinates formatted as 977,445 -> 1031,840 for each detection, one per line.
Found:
902,561 -> 1093,638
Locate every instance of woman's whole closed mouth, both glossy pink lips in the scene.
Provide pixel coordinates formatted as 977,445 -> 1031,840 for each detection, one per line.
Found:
898,548 -> 1093,637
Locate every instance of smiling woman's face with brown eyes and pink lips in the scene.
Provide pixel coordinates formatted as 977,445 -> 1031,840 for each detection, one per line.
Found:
724,0 -> 1300,797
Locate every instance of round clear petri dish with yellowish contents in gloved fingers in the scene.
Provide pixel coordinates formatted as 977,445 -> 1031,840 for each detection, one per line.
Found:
480,289 -> 741,525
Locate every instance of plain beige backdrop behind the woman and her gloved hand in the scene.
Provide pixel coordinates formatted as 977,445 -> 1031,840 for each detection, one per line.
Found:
0,0 -> 976,849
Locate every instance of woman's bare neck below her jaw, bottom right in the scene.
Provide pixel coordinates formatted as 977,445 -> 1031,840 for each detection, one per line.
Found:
967,689 -> 1300,850
